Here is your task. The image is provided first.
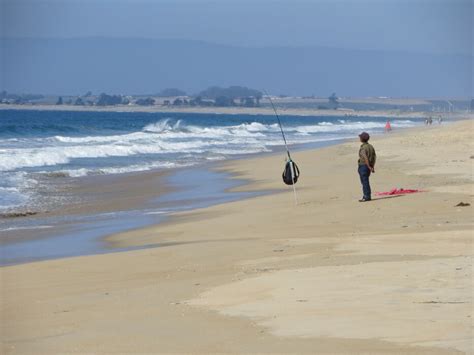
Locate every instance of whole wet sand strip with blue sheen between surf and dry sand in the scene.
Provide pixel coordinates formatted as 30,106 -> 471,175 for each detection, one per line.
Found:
0,140 -> 344,267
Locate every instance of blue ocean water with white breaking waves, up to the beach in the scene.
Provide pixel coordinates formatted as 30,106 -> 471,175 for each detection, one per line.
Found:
0,110 -> 421,213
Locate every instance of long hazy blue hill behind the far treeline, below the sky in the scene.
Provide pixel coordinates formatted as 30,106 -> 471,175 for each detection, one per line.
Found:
0,38 -> 474,97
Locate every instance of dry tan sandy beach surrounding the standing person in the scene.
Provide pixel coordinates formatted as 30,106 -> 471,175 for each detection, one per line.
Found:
0,121 -> 474,354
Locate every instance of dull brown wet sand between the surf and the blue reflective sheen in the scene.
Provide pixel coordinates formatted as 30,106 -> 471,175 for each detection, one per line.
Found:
0,171 -> 173,245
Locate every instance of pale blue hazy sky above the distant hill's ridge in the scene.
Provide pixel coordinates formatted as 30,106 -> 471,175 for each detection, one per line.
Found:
0,0 -> 474,55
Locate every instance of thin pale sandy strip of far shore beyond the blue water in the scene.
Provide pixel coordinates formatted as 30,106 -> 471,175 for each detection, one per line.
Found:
0,104 -> 474,119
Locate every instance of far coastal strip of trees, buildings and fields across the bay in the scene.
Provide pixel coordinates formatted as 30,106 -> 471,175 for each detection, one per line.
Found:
0,86 -> 474,114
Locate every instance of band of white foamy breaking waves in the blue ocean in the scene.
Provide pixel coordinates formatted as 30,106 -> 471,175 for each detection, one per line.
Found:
0,119 -> 413,173
